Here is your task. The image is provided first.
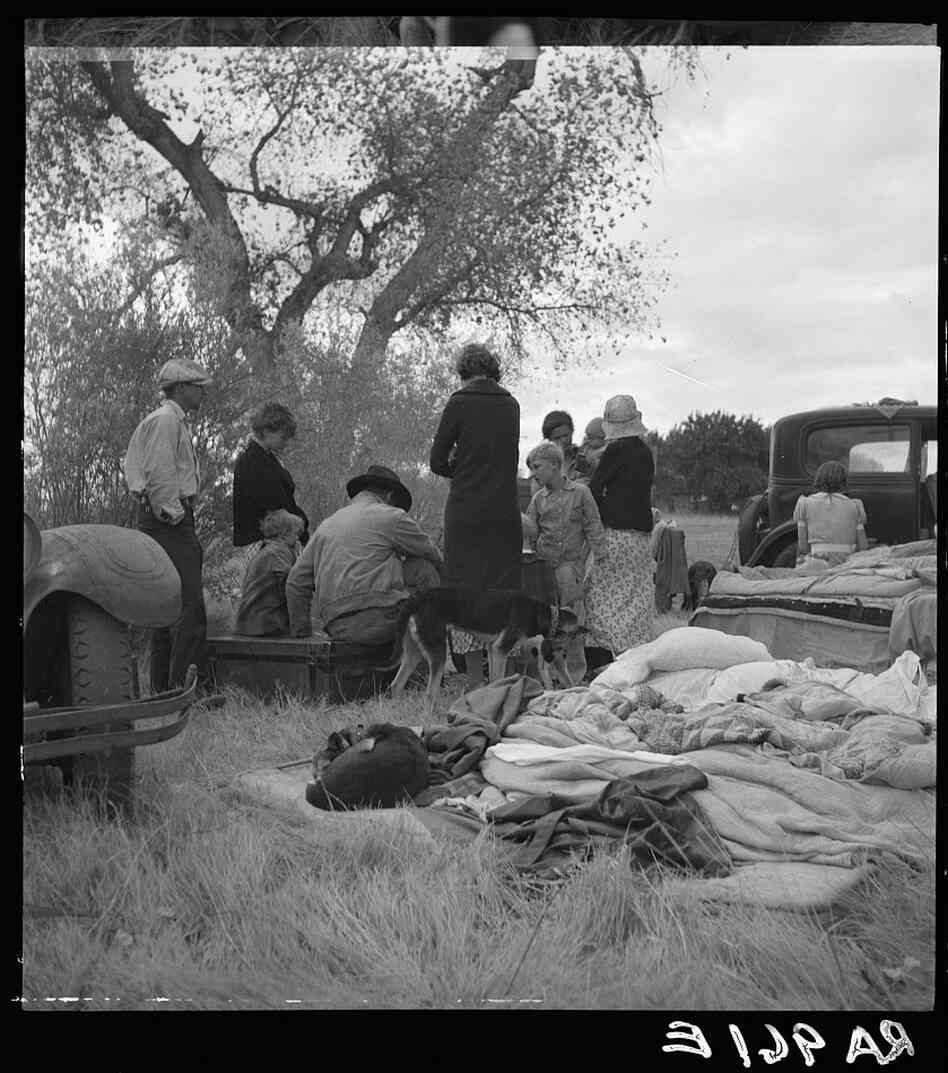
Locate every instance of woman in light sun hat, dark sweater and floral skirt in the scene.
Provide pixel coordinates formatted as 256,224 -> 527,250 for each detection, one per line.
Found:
586,395 -> 655,662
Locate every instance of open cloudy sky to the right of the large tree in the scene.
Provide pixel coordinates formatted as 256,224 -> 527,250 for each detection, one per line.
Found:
510,46 -> 938,454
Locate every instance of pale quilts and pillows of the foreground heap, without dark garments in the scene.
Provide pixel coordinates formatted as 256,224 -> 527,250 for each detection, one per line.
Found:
435,627 -> 936,908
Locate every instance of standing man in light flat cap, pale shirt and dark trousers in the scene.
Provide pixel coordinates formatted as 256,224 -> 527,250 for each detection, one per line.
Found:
125,358 -> 212,693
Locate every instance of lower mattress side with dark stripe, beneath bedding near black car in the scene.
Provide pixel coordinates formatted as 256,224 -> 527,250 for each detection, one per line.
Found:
688,597 -> 894,674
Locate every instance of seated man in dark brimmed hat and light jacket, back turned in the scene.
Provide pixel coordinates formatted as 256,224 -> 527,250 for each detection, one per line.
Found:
286,466 -> 442,645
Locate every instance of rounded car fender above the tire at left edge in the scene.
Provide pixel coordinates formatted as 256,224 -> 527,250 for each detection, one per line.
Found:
24,516 -> 181,628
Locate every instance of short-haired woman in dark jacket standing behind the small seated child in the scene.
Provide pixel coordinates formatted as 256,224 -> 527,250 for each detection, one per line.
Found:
234,402 -> 309,547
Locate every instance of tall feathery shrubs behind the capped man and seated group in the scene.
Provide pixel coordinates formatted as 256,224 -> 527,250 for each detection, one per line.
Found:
24,225 -> 454,579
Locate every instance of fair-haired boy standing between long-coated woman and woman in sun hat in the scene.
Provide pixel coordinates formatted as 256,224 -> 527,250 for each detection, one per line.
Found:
523,442 -> 605,685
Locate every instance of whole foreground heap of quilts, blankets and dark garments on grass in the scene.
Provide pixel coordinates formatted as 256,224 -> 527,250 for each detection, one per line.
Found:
238,627 -> 936,909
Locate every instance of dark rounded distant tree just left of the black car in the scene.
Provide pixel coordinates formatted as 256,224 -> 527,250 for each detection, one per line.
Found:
655,410 -> 770,511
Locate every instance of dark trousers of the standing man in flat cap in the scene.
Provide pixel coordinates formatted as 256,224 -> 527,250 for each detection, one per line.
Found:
137,502 -> 207,693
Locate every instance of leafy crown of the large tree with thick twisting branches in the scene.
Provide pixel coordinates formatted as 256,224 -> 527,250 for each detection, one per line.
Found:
27,48 -> 661,386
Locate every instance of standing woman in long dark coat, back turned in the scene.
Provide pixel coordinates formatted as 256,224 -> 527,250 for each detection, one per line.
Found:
429,343 -> 523,681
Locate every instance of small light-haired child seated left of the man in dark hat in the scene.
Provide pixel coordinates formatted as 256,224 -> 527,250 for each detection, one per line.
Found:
234,511 -> 303,637
